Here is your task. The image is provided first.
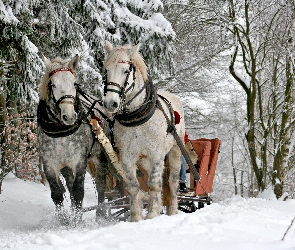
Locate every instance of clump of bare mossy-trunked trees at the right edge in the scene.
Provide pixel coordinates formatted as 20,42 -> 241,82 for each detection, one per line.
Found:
228,1 -> 294,198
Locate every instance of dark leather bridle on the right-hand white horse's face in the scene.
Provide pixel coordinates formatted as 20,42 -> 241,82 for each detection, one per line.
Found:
103,61 -> 136,103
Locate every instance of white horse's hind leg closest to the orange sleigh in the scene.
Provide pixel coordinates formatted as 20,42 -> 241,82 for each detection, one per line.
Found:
167,145 -> 181,215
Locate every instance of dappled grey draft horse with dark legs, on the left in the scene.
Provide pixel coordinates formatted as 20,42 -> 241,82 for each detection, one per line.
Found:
38,56 -> 107,223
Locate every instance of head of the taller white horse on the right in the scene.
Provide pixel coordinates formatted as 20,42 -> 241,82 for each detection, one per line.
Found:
104,41 -> 147,113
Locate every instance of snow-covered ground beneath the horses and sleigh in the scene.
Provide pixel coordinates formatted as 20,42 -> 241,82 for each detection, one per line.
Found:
0,172 -> 295,250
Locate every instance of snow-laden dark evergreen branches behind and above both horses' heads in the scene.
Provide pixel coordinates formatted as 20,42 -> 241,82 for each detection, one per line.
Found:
0,0 -> 175,187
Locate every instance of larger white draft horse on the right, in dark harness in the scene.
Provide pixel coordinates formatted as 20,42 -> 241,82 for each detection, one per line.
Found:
104,41 -> 185,221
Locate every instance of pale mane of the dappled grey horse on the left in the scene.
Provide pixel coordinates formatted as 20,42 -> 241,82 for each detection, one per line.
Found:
40,57 -> 74,100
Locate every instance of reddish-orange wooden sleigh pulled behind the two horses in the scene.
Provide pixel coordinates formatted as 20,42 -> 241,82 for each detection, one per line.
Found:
83,120 -> 221,220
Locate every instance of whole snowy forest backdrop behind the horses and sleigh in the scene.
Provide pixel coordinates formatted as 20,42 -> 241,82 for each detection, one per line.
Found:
0,0 -> 295,200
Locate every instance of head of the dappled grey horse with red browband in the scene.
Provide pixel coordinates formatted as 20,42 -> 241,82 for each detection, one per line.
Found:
41,55 -> 79,125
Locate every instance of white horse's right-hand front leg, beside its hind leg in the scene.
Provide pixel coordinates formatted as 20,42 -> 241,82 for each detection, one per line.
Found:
146,157 -> 164,219
